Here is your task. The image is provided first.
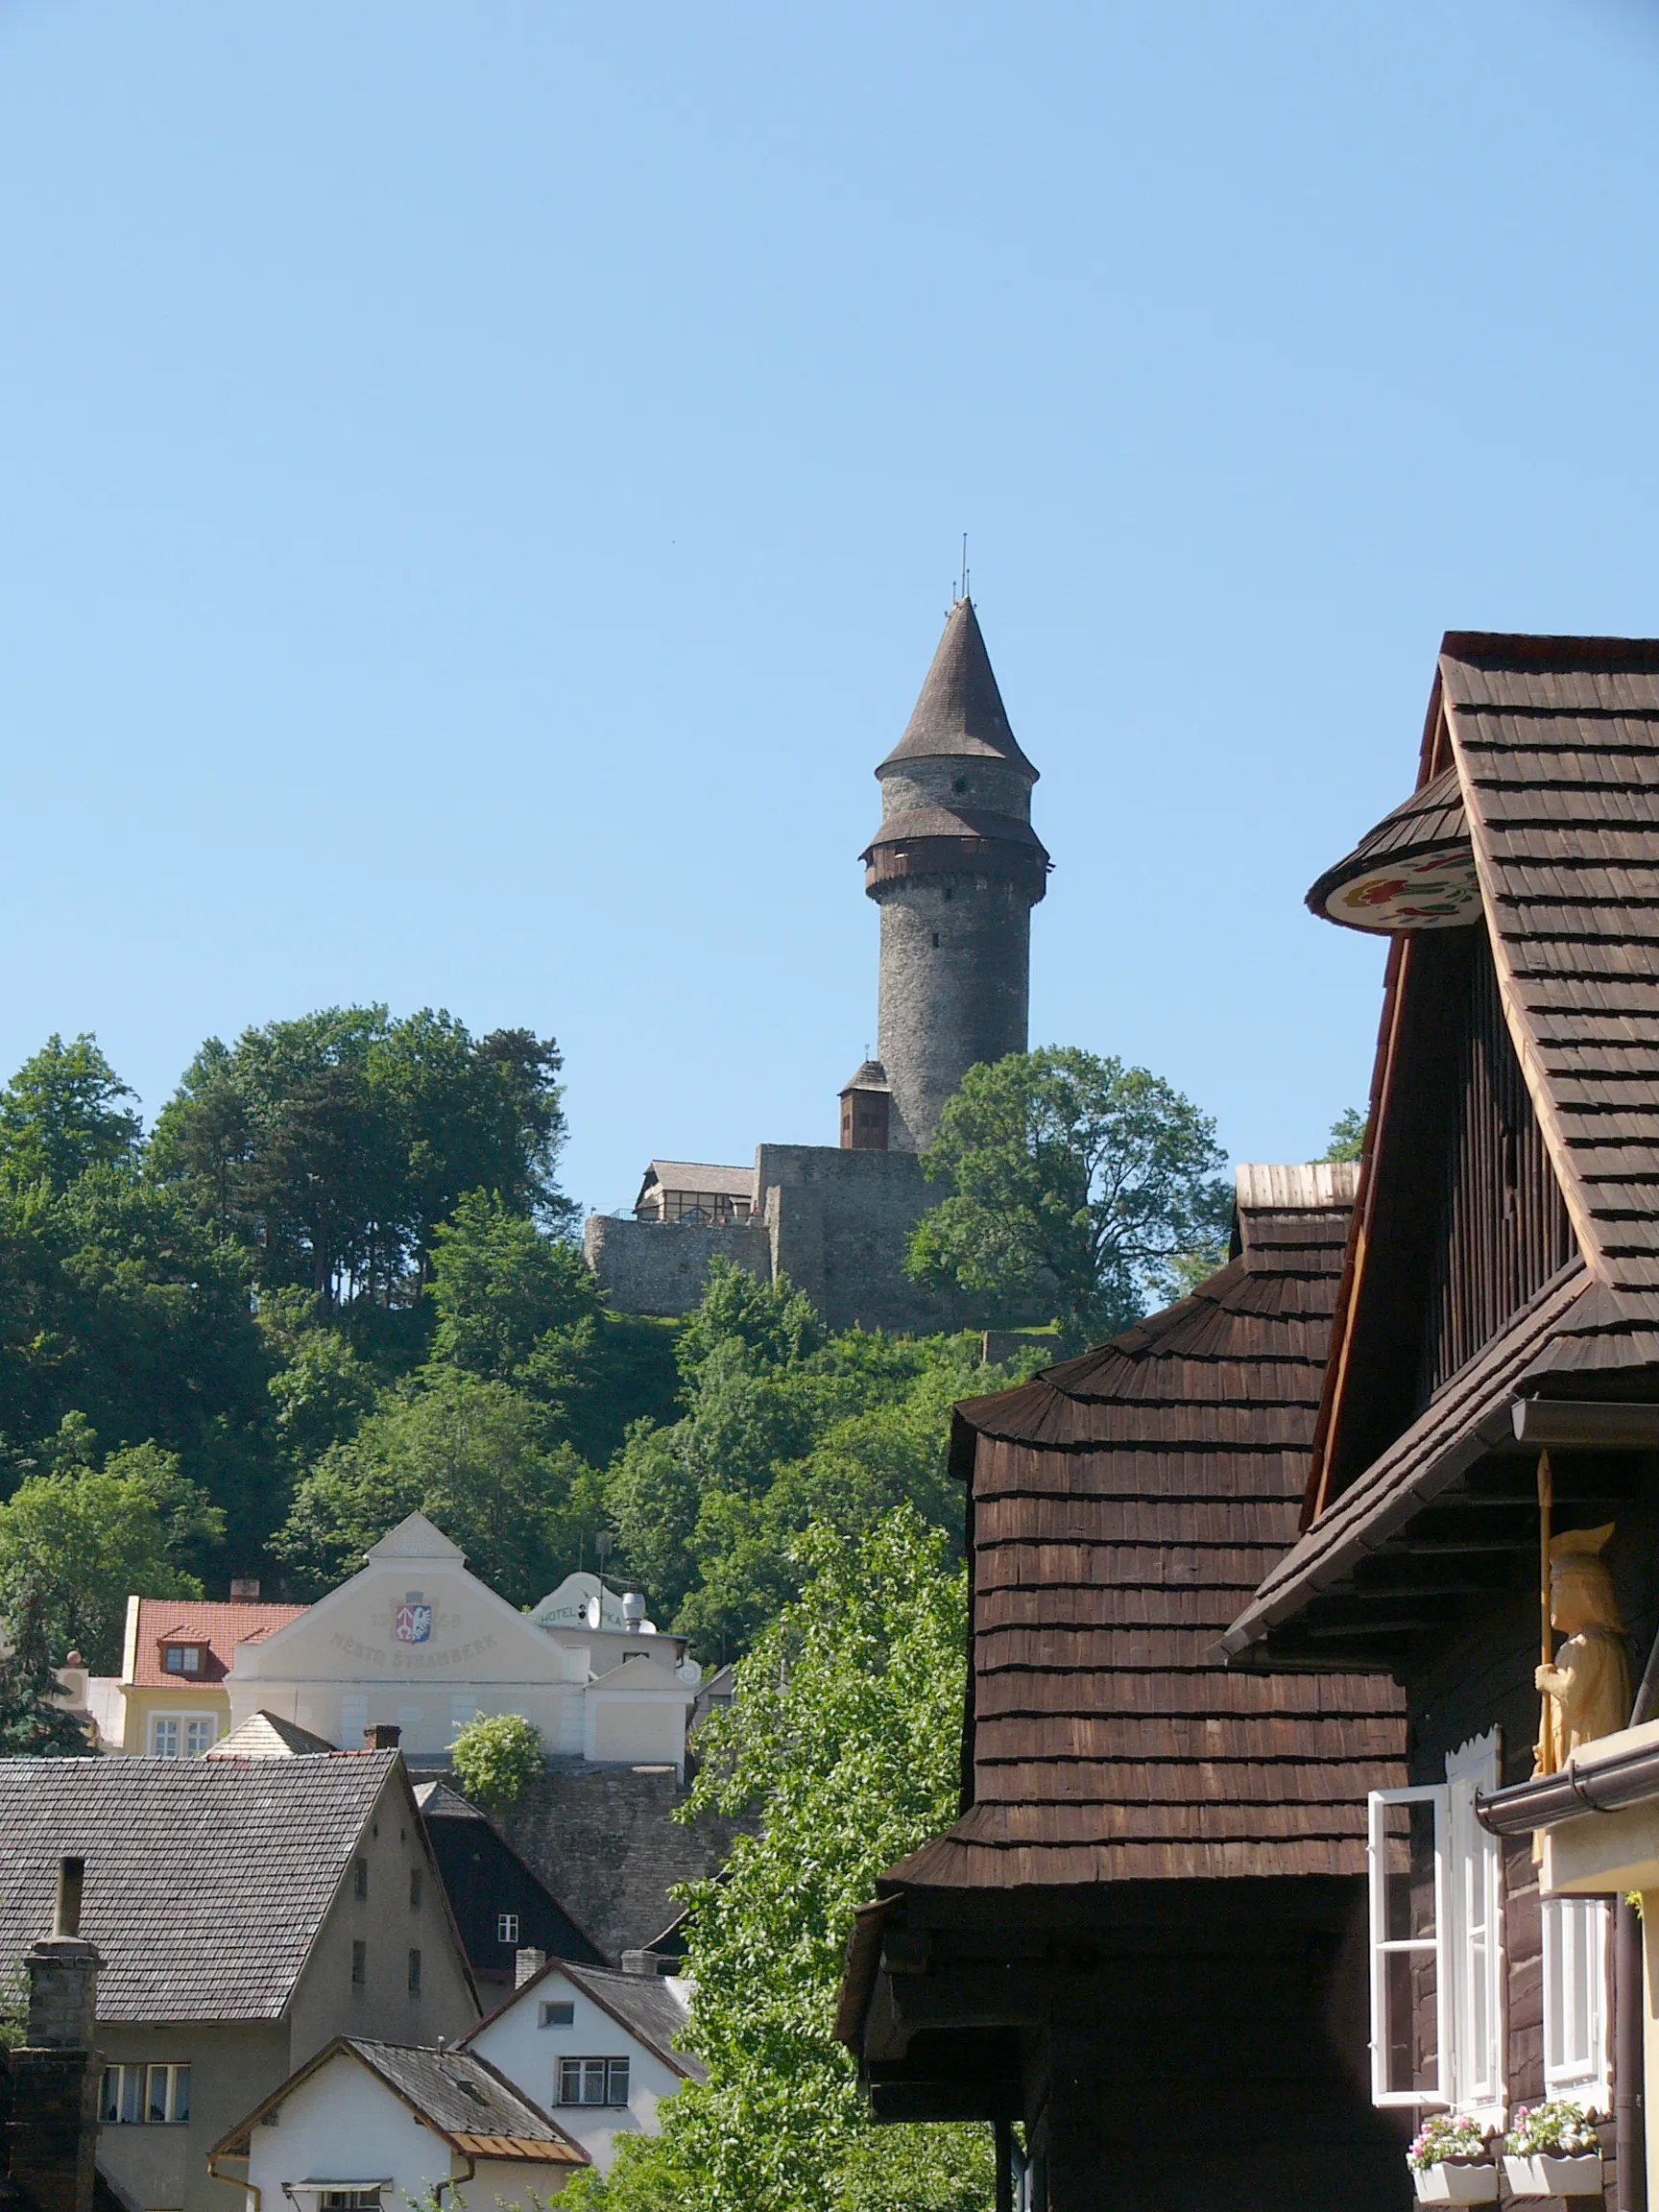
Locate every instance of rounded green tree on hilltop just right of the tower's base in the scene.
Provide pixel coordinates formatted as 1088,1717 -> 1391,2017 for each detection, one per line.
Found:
909,1046 -> 1230,1347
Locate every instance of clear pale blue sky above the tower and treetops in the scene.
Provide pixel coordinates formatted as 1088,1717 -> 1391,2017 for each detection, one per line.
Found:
0,0 -> 1659,1208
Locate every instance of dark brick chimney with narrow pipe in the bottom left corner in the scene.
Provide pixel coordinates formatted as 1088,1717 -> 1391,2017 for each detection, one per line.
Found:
9,1858 -> 104,2212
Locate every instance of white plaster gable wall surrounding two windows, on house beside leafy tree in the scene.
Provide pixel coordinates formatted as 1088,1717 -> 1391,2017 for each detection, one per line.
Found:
465,1964 -> 690,2175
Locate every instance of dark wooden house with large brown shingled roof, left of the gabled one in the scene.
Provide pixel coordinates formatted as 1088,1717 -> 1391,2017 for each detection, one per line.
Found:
838,1166 -> 1409,2212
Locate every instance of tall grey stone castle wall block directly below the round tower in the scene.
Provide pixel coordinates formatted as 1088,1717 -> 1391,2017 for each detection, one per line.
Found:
755,1143 -> 958,1334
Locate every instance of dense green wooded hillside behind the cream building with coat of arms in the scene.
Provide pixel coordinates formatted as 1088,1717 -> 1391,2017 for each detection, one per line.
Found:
0,1026 -> 1035,1666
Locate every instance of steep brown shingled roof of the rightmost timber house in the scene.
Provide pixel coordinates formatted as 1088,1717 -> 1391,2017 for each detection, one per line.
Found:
1225,633 -> 1659,1654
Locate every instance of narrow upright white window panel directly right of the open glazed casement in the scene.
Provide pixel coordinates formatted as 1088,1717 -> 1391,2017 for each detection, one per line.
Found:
1447,1730 -> 1504,2126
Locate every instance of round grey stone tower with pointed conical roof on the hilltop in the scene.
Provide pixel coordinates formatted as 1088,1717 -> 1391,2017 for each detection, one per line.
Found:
862,599 -> 1048,1152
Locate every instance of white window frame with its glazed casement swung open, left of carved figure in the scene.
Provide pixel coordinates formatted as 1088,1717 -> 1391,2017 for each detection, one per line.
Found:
1367,1727 -> 1506,2128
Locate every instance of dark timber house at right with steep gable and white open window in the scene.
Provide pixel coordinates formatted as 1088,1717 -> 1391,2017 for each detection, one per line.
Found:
1223,635 -> 1659,2212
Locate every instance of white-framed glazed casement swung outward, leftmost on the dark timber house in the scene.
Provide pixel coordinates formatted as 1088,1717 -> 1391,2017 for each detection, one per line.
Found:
1367,1783 -> 1451,2105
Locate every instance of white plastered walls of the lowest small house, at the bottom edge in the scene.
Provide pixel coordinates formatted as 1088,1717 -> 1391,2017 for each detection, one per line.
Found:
234,2051 -> 580,2212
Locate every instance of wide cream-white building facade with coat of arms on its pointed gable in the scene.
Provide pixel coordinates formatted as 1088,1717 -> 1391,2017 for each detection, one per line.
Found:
226,1513 -> 701,1772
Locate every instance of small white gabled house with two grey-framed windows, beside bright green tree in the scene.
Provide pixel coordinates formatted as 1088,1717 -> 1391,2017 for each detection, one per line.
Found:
460,1951 -> 704,2175
